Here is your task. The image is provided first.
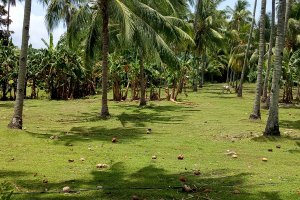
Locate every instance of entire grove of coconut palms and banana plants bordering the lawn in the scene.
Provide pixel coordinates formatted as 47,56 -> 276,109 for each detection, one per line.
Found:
0,0 -> 300,135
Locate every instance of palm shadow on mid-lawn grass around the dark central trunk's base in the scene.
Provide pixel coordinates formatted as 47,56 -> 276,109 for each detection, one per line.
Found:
26,105 -> 193,145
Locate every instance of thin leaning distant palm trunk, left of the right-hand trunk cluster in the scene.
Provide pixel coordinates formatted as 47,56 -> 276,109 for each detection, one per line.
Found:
237,0 -> 257,97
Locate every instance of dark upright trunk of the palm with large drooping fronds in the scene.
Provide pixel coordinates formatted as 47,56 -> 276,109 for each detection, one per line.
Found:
99,0 -> 109,118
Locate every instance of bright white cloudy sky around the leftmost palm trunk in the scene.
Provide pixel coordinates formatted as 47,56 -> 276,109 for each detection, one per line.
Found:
10,1 -> 65,48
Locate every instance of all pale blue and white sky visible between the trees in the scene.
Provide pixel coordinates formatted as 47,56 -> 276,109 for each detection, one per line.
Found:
10,0 -> 271,48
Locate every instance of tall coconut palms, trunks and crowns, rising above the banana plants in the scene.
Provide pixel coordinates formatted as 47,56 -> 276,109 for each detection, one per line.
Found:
4,0 -> 298,138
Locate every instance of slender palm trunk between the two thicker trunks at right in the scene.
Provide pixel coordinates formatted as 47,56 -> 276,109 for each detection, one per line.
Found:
261,0 -> 275,102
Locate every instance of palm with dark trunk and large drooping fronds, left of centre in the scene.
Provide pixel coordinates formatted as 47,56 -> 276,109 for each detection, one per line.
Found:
69,0 -> 192,117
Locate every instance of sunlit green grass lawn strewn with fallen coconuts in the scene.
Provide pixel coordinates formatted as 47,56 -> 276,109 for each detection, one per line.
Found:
0,85 -> 300,200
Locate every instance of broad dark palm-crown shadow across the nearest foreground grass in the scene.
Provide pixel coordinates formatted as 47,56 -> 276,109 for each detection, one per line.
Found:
8,162 -> 280,200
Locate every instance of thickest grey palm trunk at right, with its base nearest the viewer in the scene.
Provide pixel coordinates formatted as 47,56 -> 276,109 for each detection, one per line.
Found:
264,0 -> 286,136
